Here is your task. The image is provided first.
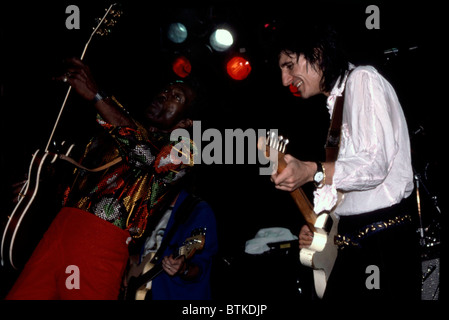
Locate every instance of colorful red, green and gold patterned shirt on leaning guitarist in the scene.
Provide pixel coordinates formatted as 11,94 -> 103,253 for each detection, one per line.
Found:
64,98 -> 195,238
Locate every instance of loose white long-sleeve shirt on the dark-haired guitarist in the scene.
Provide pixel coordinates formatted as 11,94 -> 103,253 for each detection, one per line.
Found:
314,66 -> 413,216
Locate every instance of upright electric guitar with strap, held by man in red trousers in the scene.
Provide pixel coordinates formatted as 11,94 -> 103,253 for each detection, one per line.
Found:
1,4 -> 122,269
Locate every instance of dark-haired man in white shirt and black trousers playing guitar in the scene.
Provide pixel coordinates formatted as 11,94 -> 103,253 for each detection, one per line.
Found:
272,24 -> 420,300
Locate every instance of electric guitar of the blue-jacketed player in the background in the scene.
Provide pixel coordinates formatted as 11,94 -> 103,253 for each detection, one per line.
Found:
125,228 -> 206,300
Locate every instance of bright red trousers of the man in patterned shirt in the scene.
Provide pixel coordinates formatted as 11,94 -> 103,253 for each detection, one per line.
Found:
6,208 -> 130,300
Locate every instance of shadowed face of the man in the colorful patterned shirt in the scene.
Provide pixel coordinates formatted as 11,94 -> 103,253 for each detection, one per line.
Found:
145,83 -> 193,131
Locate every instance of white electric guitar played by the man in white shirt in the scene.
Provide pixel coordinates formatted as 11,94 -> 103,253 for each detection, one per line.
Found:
258,132 -> 343,299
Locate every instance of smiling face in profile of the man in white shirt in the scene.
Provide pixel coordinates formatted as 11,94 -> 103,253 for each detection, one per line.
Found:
279,52 -> 323,99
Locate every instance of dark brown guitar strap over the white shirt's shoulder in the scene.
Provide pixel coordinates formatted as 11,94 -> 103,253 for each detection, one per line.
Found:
325,69 -> 354,162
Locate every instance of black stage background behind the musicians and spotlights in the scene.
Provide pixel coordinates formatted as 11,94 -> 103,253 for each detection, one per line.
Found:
0,0 -> 447,300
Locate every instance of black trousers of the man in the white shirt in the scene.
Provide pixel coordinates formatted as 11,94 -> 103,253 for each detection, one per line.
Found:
323,200 -> 421,301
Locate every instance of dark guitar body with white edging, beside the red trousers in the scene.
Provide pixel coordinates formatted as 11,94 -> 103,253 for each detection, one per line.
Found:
1,145 -> 74,269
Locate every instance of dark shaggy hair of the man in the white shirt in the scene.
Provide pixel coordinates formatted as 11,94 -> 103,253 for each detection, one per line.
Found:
276,22 -> 349,92
